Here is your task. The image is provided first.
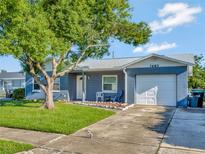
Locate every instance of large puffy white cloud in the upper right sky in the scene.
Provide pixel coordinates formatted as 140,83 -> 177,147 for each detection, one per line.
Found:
150,3 -> 202,32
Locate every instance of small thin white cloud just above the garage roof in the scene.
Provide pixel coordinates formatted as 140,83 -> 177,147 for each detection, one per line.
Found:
133,42 -> 177,53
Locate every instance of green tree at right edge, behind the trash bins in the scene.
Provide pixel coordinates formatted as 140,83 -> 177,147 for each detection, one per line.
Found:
189,55 -> 205,89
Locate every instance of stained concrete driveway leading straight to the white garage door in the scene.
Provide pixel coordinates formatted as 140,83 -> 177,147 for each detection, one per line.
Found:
40,106 -> 175,154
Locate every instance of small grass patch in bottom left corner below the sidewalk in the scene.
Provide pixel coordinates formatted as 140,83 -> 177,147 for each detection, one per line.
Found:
0,140 -> 33,154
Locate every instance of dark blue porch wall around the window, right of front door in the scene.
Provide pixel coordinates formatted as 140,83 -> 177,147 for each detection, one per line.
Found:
85,71 -> 125,101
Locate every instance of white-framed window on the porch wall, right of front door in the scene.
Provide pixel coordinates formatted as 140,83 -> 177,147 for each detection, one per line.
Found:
102,75 -> 117,93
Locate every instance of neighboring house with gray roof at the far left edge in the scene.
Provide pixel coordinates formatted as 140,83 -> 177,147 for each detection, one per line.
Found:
0,70 -> 25,91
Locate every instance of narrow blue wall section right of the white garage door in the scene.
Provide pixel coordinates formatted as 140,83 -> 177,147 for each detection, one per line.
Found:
177,71 -> 188,106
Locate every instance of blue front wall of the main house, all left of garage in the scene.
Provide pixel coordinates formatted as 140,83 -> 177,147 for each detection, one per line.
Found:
26,71 -> 125,101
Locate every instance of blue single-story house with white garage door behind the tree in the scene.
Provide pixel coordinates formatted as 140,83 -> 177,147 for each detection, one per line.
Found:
26,54 -> 194,106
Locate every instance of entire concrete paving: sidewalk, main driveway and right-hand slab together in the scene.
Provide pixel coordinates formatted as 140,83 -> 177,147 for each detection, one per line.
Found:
0,106 -> 205,154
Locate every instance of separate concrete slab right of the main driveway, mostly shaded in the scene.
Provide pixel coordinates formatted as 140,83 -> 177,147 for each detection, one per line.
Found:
159,108 -> 205,154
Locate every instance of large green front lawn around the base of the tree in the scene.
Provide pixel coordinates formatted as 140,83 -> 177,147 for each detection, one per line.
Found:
0,101 -> 114,134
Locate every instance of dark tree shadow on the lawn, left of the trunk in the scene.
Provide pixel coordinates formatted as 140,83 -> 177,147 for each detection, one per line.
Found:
0,100 -> 42,108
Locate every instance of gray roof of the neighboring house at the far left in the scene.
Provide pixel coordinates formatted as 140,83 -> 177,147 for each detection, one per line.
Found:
0,71 -> 25,79
